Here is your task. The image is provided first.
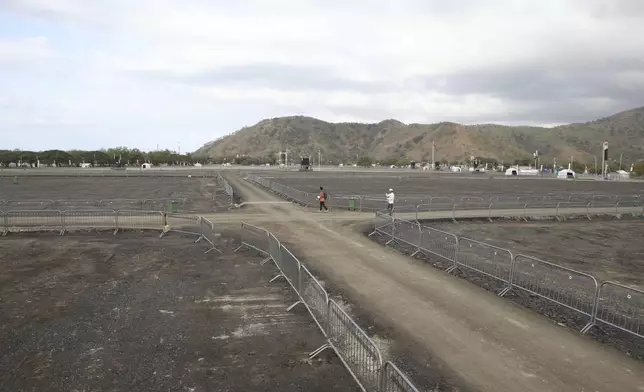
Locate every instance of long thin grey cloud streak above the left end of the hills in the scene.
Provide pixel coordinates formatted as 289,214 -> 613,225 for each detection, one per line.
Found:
135,64 -> 396,93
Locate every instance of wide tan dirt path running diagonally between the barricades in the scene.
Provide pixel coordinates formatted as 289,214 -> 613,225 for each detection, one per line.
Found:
229,176 -> 644,392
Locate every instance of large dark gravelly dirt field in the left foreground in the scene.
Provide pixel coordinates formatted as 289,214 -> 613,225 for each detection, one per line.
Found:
0,232 -> 355,392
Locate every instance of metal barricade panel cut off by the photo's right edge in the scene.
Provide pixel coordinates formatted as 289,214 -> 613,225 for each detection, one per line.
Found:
582,282 -> 644,338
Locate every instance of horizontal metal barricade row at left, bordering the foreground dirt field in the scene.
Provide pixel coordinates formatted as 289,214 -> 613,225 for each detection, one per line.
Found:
0,210 -> 219,251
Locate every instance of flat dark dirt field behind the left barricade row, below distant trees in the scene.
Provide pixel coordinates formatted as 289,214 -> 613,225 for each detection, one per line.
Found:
0,175 -> 228,212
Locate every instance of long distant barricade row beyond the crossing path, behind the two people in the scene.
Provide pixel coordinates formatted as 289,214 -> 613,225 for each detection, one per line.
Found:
247,174 -> 644,213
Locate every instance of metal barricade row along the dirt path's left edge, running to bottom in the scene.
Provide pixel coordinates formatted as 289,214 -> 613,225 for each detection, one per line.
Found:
238,223 -> 418,392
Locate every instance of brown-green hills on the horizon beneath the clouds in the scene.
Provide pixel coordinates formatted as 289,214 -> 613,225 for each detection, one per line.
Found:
194,107 -> 644,163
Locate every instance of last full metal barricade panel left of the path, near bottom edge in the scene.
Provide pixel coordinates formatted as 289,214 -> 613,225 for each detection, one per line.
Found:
327,300 -> 383,390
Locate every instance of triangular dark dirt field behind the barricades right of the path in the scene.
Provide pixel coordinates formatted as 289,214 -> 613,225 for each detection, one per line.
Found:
424,220 -> 644,288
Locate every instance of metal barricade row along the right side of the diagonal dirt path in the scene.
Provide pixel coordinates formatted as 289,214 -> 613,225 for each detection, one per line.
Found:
369,212 -> 644,338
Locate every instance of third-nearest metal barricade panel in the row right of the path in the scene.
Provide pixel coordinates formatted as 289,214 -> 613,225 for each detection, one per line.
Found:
456,237 -> 514,288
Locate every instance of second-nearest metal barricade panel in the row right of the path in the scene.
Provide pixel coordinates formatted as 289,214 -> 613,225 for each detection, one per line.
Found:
512,255 -> 598,328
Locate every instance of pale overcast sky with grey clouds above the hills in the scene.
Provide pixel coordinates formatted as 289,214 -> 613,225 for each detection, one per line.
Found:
0,0 -> 644,151
